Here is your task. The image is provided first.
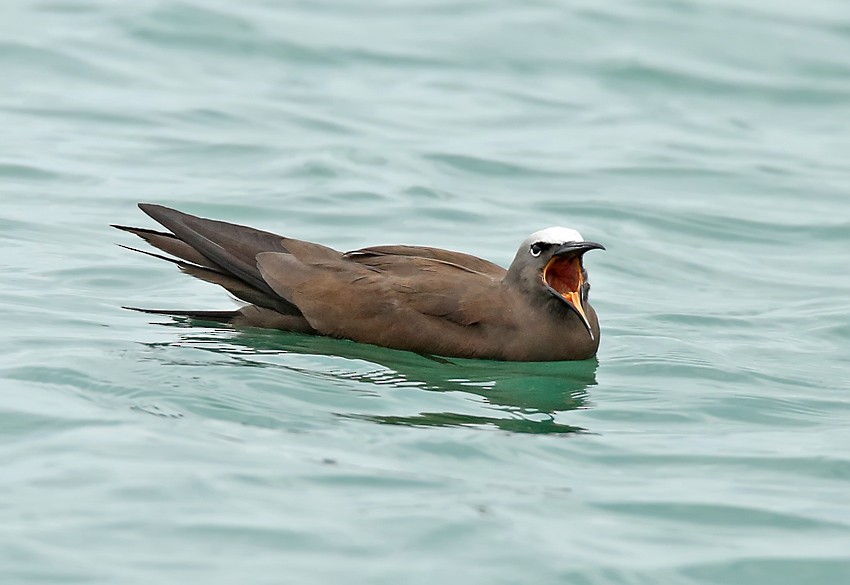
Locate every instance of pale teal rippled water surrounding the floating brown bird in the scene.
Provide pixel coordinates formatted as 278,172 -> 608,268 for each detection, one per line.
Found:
0,0 -> 850,585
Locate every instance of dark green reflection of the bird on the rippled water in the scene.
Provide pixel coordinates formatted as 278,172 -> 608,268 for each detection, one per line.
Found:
149,317 -> 598,434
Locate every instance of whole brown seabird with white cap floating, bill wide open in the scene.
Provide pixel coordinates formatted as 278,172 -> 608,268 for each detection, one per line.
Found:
113,203 -> 605,361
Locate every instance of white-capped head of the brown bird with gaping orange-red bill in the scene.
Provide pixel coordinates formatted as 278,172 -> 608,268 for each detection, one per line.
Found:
506,227 -> 605,338
